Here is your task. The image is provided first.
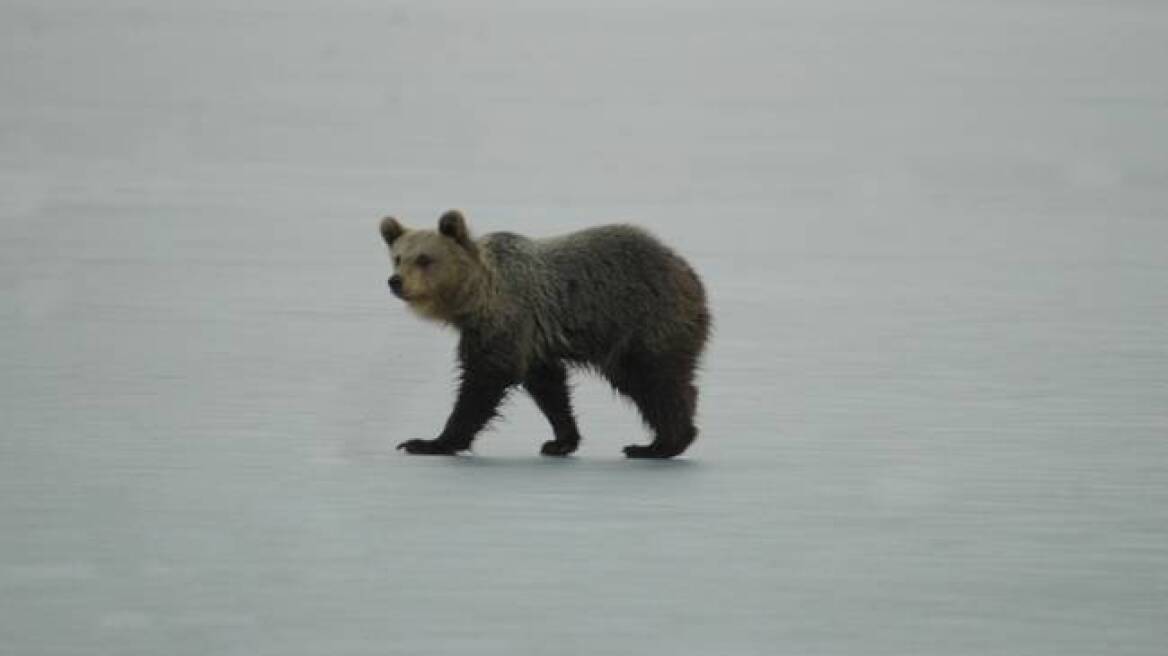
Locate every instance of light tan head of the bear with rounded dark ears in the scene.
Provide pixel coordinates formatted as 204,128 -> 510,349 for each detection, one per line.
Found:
381,210 -> 485,323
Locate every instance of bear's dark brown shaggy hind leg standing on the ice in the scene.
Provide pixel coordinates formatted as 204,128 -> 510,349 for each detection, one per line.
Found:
609,350 -> 697,458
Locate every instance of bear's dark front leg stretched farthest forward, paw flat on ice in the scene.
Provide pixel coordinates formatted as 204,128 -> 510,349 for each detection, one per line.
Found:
397,361 -> 513,455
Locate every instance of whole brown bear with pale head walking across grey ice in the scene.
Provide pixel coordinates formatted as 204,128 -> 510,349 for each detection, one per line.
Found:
381,210 -> 710,458
